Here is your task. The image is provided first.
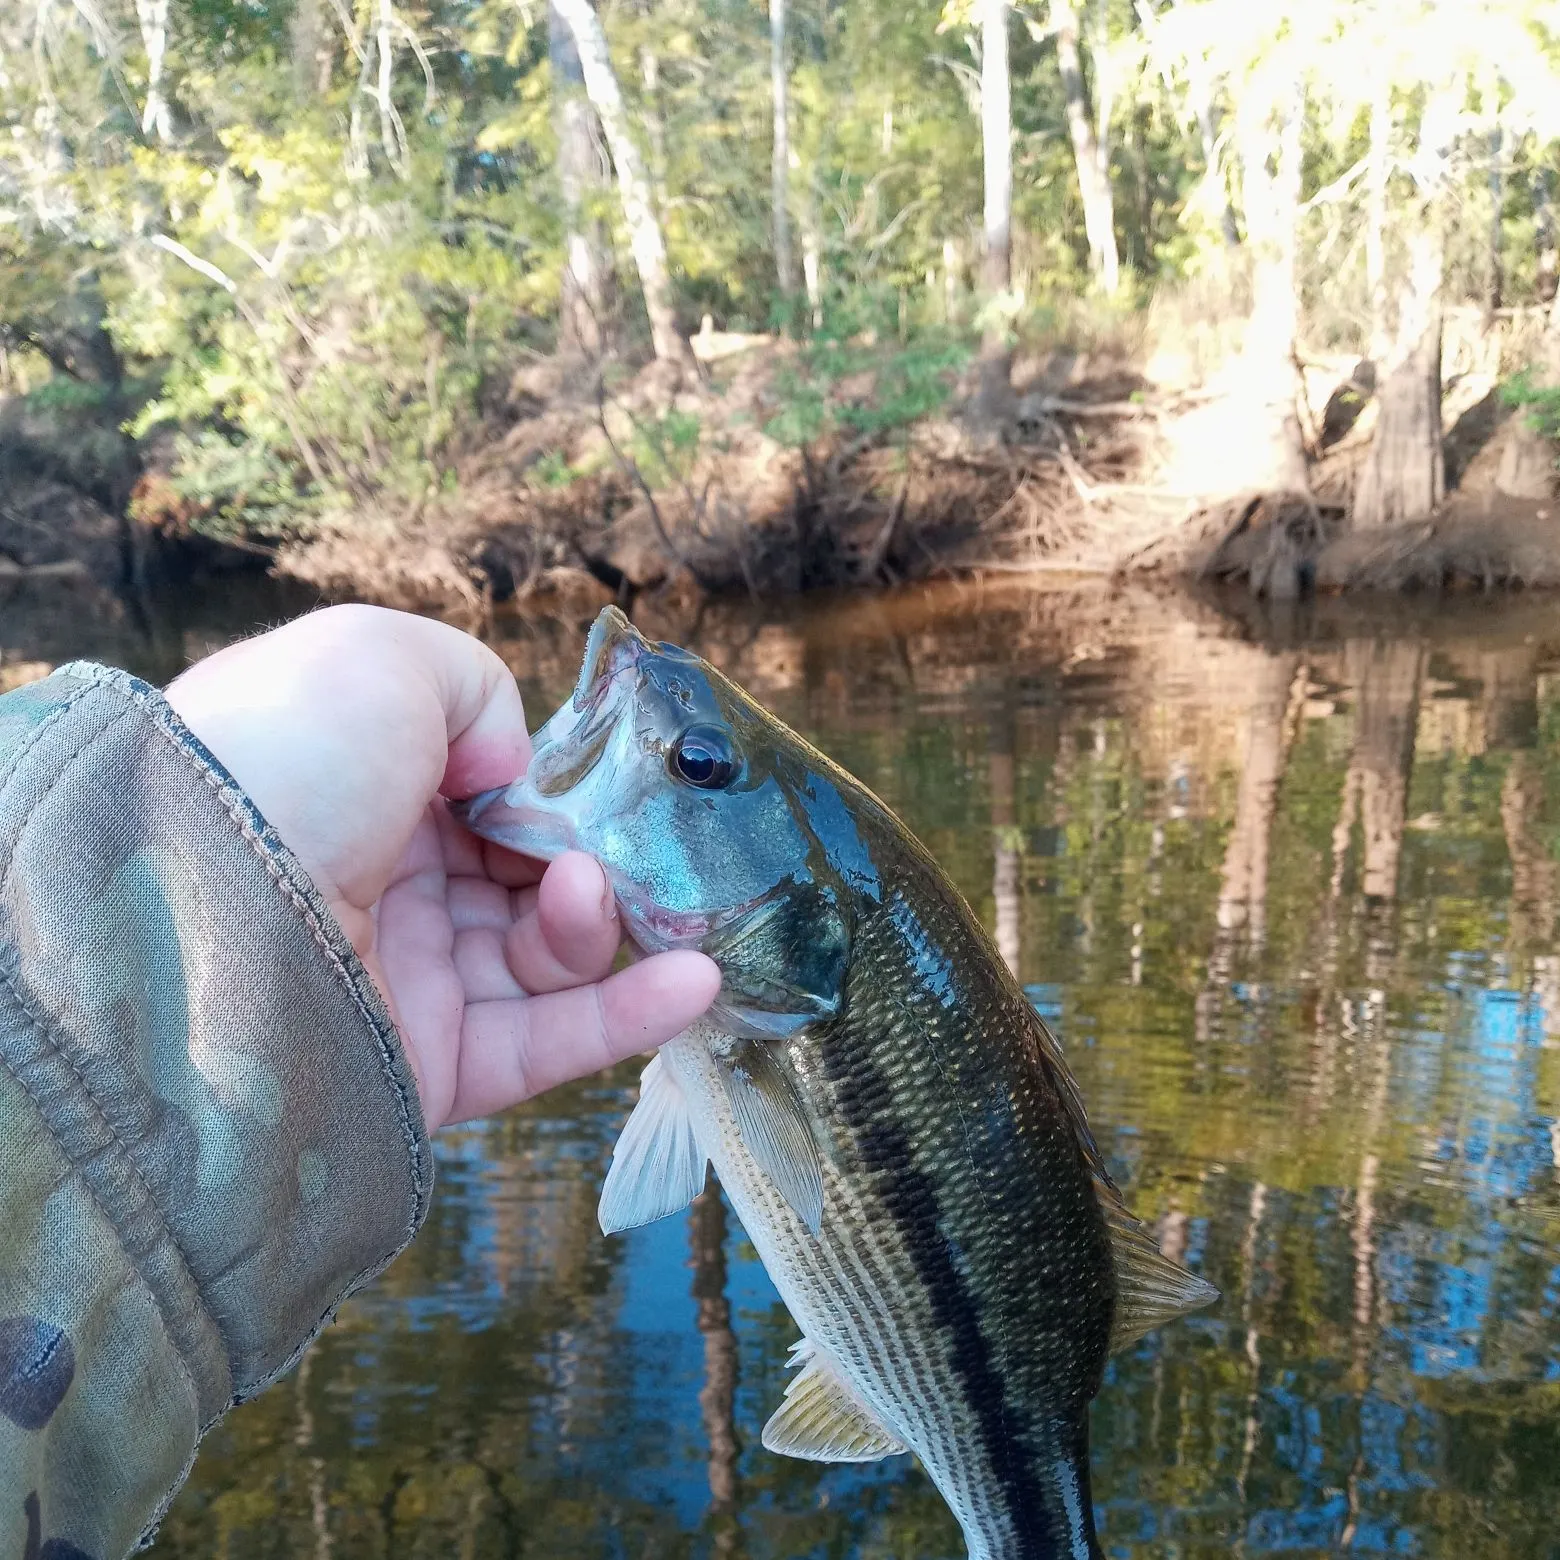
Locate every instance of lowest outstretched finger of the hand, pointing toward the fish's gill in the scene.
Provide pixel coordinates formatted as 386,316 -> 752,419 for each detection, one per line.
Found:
451,950 -> 721,1120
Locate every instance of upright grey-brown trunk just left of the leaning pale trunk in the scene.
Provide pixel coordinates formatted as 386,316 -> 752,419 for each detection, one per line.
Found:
548,3 -> 608,357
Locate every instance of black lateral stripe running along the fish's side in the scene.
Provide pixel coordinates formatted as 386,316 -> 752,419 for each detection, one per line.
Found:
821,1044 -> 1061,1560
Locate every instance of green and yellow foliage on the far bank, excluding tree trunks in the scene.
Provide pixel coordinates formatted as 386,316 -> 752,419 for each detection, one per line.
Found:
9,0 -> 1560,555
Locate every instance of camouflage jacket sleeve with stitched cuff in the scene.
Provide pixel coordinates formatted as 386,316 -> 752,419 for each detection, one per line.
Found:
0,663 -> 432,1560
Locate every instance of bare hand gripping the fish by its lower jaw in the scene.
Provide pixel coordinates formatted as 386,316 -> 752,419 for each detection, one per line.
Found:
167,607 -> 719,1131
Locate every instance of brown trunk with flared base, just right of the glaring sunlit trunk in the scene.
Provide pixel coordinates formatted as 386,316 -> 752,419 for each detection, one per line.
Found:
1353,218 -> 1446,529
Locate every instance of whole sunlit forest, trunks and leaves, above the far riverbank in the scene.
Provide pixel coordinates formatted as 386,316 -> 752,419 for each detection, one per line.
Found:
0,0 -> 1560,564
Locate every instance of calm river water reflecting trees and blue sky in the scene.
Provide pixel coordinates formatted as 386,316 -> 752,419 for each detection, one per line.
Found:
12,587 -> 1560,1560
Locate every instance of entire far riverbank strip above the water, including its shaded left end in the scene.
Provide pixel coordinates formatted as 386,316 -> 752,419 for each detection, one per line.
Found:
0,322 -> 1560,618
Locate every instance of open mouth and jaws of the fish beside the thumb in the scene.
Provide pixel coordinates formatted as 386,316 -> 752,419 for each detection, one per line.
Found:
451,607 -> 652,861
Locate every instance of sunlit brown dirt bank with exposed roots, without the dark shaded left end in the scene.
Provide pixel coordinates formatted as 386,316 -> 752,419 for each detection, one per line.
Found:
281,337 -> 1560,610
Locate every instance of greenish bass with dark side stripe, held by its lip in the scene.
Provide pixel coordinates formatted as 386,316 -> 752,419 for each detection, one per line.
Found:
459,607 -> 1218,1560
